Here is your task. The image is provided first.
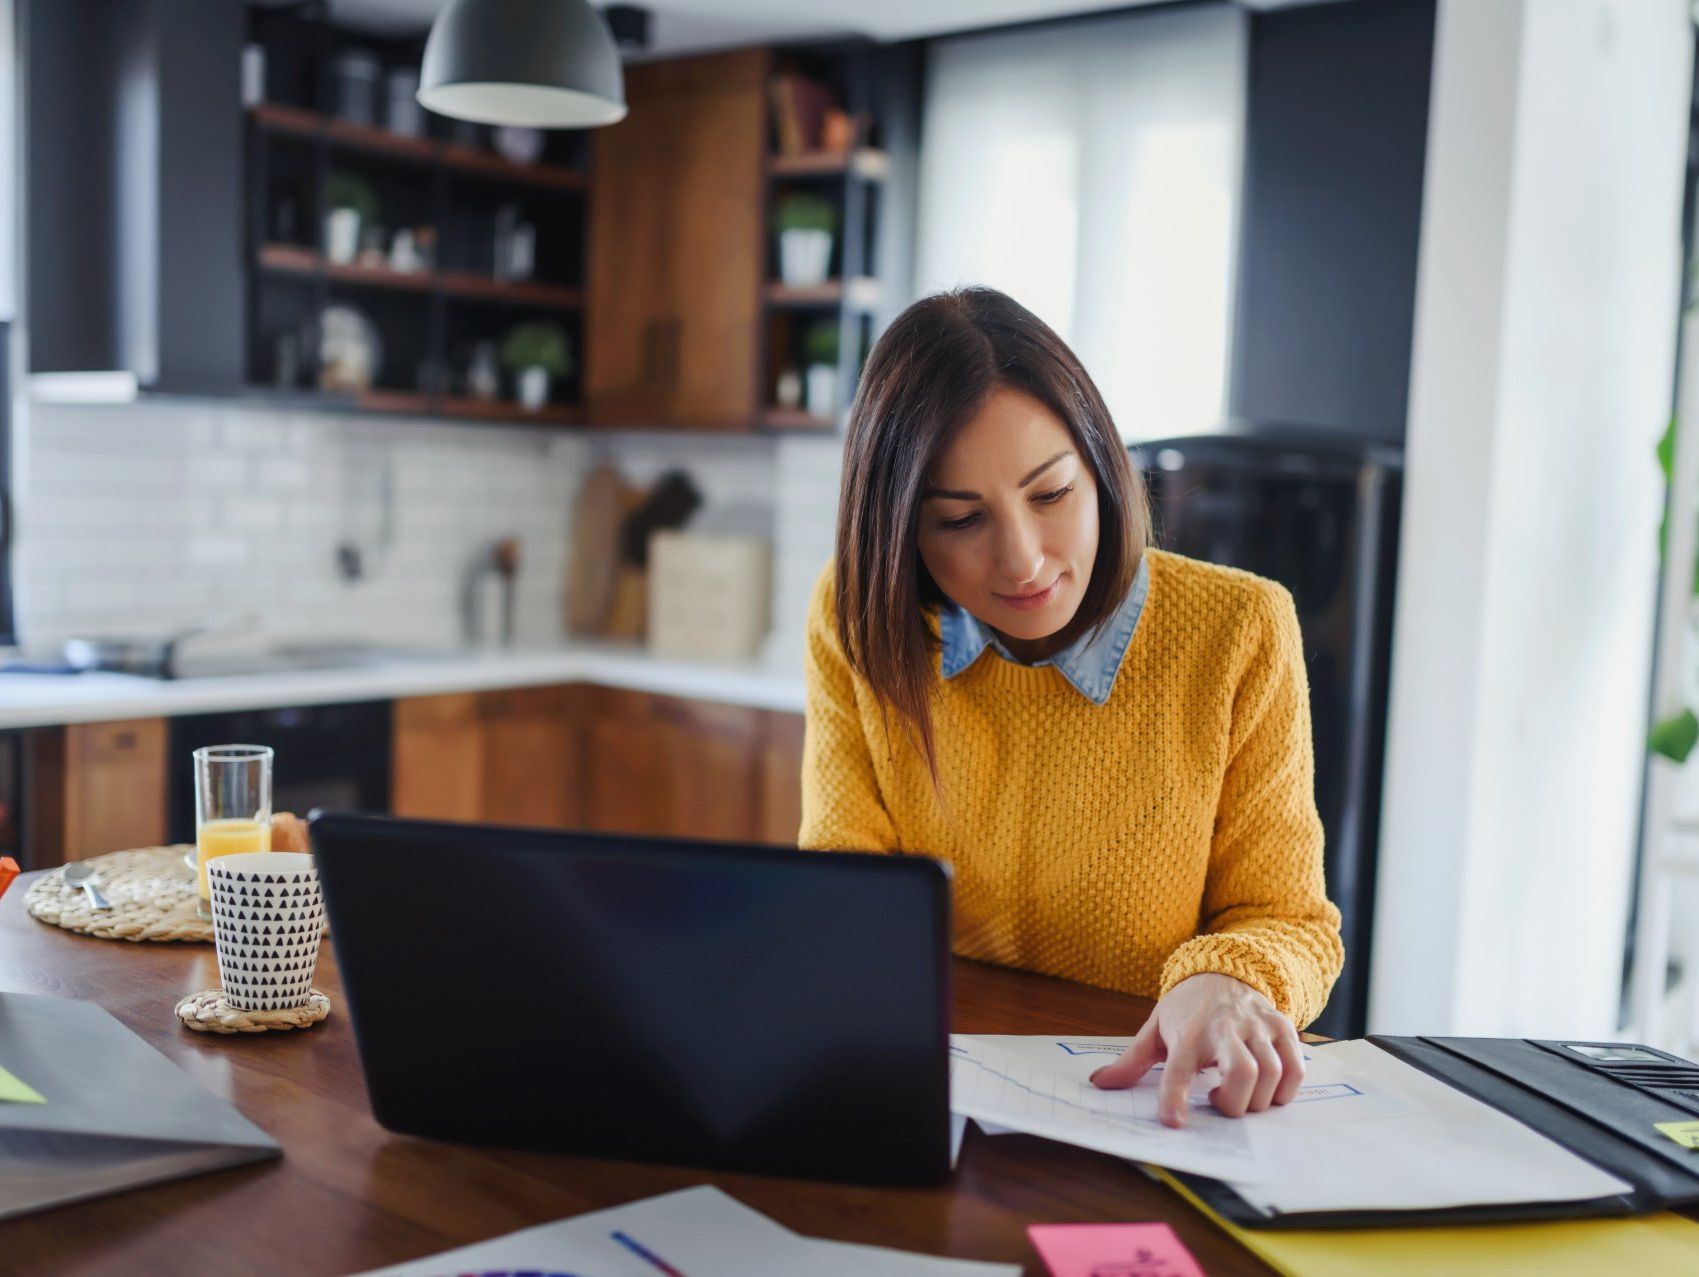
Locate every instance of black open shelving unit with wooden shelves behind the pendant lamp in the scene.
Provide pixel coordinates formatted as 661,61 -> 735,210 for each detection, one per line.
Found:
243,5 -> 590,425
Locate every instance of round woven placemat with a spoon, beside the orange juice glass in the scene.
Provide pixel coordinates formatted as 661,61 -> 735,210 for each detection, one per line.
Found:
24,844 -> 212,944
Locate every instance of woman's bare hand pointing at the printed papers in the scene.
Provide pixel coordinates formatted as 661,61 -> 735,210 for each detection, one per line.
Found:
1091,971 -> 1303,1128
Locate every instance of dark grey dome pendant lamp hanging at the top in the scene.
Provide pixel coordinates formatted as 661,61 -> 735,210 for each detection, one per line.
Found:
418,0 -> 625,129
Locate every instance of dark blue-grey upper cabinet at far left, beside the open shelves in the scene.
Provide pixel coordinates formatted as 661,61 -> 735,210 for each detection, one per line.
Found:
20,0 -> 245,394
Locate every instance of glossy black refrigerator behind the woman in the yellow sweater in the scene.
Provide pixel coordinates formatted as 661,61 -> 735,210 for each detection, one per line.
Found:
1132,428 -> 1403,1038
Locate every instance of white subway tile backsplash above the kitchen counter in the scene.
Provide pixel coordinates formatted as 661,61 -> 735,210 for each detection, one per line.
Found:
17,401 -> 838,662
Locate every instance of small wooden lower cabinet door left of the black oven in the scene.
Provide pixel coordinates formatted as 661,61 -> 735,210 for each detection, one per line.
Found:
29,718 -> 165,868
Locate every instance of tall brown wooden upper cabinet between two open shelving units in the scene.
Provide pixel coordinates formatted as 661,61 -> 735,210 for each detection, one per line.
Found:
584,49 -> 768,430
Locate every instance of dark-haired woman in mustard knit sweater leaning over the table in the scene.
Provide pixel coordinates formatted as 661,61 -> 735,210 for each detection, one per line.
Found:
800,289 -> 1342,1126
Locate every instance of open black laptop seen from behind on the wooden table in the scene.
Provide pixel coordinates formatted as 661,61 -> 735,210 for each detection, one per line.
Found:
309,815 -> 950,1184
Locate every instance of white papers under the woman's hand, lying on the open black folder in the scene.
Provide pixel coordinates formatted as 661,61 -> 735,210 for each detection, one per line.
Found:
950,1036 -> 1631,1216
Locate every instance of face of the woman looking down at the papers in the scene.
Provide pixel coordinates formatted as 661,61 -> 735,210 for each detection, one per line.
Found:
919,389 -> 1098,661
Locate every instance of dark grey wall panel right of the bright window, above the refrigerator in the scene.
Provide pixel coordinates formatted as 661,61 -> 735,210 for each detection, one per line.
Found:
1230,0 -> 1434,442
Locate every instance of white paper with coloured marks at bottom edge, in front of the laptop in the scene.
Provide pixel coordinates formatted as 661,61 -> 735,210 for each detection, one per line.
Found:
367,1185 -> 1021,1277
